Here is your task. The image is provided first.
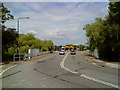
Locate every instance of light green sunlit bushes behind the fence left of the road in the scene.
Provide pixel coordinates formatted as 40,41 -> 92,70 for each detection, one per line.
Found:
3,33 -> 54,59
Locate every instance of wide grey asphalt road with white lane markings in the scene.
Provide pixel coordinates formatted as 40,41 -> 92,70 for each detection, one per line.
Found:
1,52 -> 119,88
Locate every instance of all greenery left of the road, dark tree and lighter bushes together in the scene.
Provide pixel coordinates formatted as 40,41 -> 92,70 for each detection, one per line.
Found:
0,3 -> 54,60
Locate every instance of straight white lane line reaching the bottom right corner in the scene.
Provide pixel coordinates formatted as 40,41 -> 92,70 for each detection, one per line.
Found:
80,74 -> 119,88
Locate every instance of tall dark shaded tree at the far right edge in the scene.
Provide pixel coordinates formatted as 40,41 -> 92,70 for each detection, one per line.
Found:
107,1 -> 120,59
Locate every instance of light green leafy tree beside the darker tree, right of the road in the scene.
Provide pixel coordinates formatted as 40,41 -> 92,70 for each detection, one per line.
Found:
83,18 -> 106,51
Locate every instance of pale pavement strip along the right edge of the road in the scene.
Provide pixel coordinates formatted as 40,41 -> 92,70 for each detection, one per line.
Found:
81,51 -> 120,69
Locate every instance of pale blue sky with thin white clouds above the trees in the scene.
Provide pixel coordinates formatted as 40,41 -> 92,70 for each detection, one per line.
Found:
4,2 -> 108,45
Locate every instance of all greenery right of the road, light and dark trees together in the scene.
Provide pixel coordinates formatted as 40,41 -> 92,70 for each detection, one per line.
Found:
83,2 -> 120,61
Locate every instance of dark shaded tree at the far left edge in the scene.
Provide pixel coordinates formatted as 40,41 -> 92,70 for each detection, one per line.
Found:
0,3 -> 16,60
